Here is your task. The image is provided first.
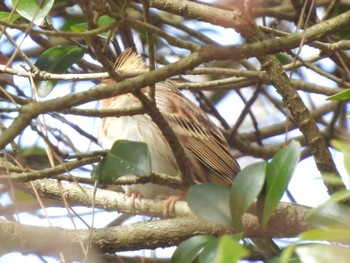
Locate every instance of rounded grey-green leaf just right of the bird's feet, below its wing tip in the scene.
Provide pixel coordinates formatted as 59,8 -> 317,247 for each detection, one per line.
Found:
187,183 -> 232,226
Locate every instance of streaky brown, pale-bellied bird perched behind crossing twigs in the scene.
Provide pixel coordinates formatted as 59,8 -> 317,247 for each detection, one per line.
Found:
98,49 -> 240,211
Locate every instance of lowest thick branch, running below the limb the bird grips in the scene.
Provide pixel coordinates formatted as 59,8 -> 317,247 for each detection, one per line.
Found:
0,205 -> 306,259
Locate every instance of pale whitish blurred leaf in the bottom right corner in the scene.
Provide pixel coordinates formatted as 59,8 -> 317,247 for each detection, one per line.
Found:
295,244 -> 350,263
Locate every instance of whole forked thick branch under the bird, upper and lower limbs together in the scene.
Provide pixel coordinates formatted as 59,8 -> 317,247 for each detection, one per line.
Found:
0,180 -> 308,258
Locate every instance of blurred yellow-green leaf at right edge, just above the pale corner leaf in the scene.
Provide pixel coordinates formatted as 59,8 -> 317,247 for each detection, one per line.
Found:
299,228 -> 350,244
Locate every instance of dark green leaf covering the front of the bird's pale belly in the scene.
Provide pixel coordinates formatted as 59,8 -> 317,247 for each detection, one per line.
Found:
91,140 -> 152,183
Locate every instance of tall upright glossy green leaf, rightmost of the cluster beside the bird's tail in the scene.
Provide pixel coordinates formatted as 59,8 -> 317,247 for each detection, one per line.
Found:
258,141 -> 301,227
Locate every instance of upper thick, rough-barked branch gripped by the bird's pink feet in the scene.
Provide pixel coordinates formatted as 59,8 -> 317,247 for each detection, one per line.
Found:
8,180 -> 308,234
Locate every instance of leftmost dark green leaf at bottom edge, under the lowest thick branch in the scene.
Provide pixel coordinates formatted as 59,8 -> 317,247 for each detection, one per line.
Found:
171,235 -> 216,263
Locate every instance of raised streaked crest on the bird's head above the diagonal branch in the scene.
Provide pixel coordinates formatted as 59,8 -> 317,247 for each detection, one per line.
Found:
114,48 -> 147,71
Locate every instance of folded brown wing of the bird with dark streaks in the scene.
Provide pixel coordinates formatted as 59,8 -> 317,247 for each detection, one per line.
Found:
156,81 -> 240,185
